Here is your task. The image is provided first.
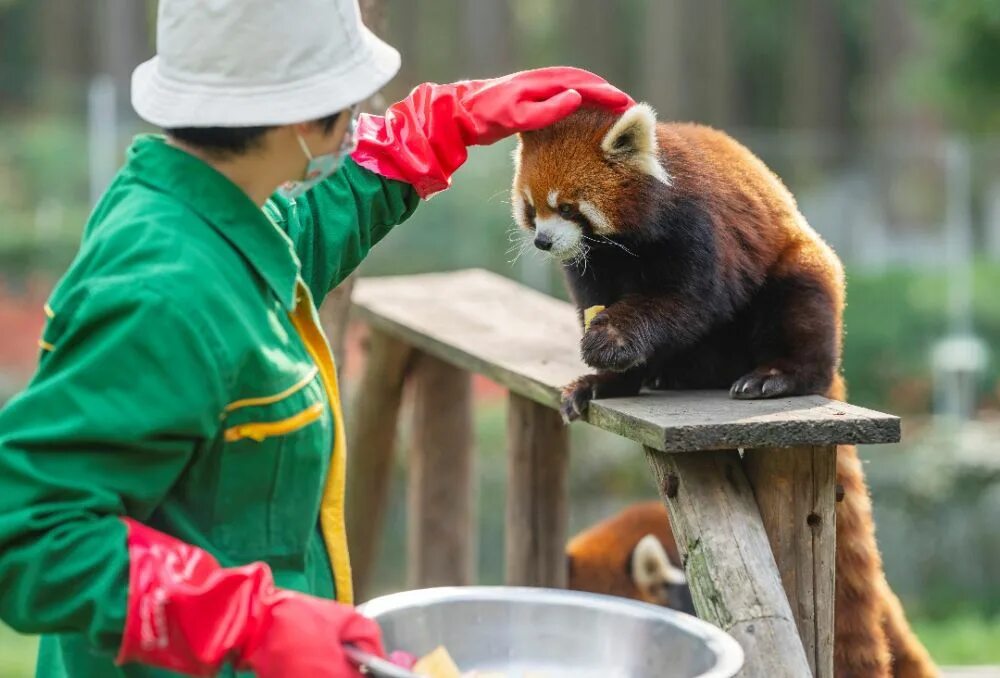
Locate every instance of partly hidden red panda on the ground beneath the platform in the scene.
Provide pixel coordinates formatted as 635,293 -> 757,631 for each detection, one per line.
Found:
566,501 -> 694,614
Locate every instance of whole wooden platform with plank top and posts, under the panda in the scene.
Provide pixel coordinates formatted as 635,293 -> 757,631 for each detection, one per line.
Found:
348,271 -> 899,678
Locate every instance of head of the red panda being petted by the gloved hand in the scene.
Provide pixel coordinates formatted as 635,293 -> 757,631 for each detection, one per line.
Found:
511,104 -> 670,261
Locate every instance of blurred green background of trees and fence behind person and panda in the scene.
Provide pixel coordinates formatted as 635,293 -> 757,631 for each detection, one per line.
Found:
0,0 -> 1000,678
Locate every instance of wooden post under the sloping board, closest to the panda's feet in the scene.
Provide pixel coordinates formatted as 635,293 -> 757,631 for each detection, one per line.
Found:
506,393 -> 569,588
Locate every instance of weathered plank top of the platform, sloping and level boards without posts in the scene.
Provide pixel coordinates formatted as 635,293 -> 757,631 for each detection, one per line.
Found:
354,270 -> 899,452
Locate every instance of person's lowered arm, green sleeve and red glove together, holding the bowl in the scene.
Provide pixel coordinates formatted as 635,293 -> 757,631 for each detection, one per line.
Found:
0,283 -> 381,676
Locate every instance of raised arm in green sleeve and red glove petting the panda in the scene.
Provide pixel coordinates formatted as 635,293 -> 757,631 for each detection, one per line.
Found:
265,67 -> 635,303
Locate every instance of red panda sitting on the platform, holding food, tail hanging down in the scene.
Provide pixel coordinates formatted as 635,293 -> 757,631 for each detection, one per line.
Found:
511,104 -> 936,678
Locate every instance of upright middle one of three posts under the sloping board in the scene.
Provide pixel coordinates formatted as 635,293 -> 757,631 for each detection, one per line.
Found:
407,354 -> 475,588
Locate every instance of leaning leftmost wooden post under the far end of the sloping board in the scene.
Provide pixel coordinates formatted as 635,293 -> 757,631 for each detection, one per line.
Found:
346,330 -> 413,600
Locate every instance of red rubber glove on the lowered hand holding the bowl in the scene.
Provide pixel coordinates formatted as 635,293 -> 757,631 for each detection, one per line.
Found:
117,518 -> 385,678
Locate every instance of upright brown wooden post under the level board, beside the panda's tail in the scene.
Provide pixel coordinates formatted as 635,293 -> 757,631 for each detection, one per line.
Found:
743,447 -> 837,678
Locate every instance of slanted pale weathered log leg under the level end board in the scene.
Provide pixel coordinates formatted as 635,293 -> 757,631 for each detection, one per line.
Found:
646,447 -> 810,678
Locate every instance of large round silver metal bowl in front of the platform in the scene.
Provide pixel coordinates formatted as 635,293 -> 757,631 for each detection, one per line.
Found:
359,586 -> 743,678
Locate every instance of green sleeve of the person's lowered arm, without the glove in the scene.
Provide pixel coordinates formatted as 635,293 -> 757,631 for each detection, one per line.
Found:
0,286 -> 224,650
